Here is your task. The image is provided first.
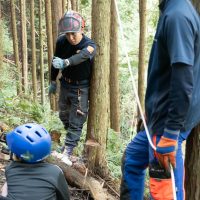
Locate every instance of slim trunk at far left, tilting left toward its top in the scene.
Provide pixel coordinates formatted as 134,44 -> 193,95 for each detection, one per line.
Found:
10,0 -> 22,95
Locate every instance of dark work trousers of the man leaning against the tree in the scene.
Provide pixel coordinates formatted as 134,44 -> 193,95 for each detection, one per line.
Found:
59,85 -> 89,147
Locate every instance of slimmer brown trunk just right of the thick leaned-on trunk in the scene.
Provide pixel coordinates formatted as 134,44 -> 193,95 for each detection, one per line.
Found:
110,0 -> 120,132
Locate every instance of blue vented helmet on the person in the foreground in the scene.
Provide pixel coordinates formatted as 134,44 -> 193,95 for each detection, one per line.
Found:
6,123 -> 51,163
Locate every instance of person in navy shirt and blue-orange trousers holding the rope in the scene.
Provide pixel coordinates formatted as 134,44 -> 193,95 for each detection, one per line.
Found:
121,0 -> 200,200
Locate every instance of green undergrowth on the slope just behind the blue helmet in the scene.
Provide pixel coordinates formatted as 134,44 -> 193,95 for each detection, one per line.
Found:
0,91 -> 63,135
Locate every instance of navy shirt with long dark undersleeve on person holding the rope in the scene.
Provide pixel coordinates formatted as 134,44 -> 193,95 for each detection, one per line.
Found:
145,0 -> 200,134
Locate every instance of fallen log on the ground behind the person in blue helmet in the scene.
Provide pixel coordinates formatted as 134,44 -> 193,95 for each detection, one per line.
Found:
47,152 -> 118,200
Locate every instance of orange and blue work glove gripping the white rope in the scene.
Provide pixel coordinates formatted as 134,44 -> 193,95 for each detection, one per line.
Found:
156,132 -> 178,171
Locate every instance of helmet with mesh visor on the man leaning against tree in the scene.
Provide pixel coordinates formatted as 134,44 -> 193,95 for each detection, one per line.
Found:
58,10 -> 85,34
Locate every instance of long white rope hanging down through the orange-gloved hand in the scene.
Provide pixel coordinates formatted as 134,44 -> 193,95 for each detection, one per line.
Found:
114,0 -> 177,200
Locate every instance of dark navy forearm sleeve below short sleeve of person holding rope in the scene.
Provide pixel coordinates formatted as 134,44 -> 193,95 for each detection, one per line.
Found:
165,63 -> 193,133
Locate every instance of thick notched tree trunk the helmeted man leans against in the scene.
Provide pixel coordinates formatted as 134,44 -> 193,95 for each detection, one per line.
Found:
85,0 -> 110,176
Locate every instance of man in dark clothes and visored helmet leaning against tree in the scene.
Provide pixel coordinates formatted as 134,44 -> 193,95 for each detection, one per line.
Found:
49,11 -> 96,165
